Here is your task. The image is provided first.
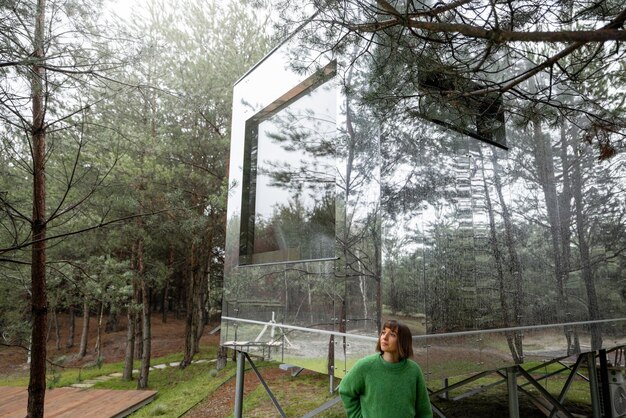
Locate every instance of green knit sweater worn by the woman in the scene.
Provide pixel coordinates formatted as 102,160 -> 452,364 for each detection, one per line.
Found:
339,354 -> 433,418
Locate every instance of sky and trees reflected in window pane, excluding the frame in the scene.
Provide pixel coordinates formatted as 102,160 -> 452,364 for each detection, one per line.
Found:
253,78 -> 336,263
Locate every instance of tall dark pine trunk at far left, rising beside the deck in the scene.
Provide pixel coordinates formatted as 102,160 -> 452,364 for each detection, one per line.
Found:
26,0 -> 48,418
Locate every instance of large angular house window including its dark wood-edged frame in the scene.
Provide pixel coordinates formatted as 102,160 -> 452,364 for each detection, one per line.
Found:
239,62 -> 337,264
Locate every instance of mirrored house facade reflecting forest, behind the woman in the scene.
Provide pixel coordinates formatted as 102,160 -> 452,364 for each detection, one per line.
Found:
221,24 -> 626,379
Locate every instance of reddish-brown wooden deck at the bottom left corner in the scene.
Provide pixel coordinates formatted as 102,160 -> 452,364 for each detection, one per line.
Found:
0,386 -> 157,418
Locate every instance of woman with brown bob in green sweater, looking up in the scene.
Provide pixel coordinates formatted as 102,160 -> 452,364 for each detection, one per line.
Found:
339,320 -> 433,418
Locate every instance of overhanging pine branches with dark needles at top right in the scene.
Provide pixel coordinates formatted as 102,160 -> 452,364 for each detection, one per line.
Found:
261,0 -> 626,158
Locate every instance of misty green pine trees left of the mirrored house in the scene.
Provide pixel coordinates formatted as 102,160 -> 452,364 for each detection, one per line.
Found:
0,0 -> 269,416
